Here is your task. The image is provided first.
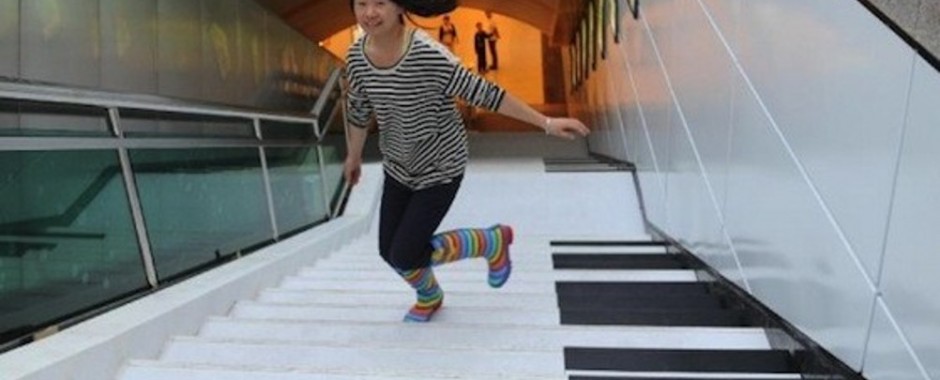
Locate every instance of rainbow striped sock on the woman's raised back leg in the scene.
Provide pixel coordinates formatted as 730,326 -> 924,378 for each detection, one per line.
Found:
431,224 -> 513,288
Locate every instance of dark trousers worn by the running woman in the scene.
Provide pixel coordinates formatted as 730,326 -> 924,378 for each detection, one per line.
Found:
379,174 -> 463,270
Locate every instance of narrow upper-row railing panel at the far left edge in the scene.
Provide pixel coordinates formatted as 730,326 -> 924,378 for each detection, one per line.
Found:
0,99 -> 111,137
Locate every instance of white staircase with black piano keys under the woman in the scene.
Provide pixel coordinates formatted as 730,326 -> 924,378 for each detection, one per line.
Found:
117,156 -> 800,380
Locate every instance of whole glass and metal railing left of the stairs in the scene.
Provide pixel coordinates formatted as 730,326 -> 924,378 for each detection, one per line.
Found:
0,72 -> 345,348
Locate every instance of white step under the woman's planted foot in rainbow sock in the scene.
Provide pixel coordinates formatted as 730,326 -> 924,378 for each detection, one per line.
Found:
230,297 -> 560,326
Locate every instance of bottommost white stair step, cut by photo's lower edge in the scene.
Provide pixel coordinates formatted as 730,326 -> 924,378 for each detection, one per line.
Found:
118,360 -> 565,380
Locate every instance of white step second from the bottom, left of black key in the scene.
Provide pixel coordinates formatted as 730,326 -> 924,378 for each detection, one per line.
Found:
160,338 -> 564,379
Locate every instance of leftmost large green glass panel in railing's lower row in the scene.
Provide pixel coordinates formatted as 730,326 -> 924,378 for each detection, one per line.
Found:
0,151 -> 147,341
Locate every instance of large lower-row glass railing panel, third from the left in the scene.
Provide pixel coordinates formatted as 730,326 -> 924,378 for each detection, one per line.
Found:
265,147 -> 327,236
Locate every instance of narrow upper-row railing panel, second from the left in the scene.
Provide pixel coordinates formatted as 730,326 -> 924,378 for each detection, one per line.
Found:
121,110 -> 255,138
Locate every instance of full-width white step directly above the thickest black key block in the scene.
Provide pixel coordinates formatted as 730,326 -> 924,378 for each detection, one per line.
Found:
298,266 -> 698,284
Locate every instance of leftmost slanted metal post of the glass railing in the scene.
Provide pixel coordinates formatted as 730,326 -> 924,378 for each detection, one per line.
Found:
108,107 -> 159,288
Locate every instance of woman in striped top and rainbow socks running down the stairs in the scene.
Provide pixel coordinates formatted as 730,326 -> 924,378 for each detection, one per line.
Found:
344,0 -> 588,322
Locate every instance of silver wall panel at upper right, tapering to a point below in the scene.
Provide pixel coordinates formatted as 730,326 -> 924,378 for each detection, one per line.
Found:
739,0 -> 912,277
